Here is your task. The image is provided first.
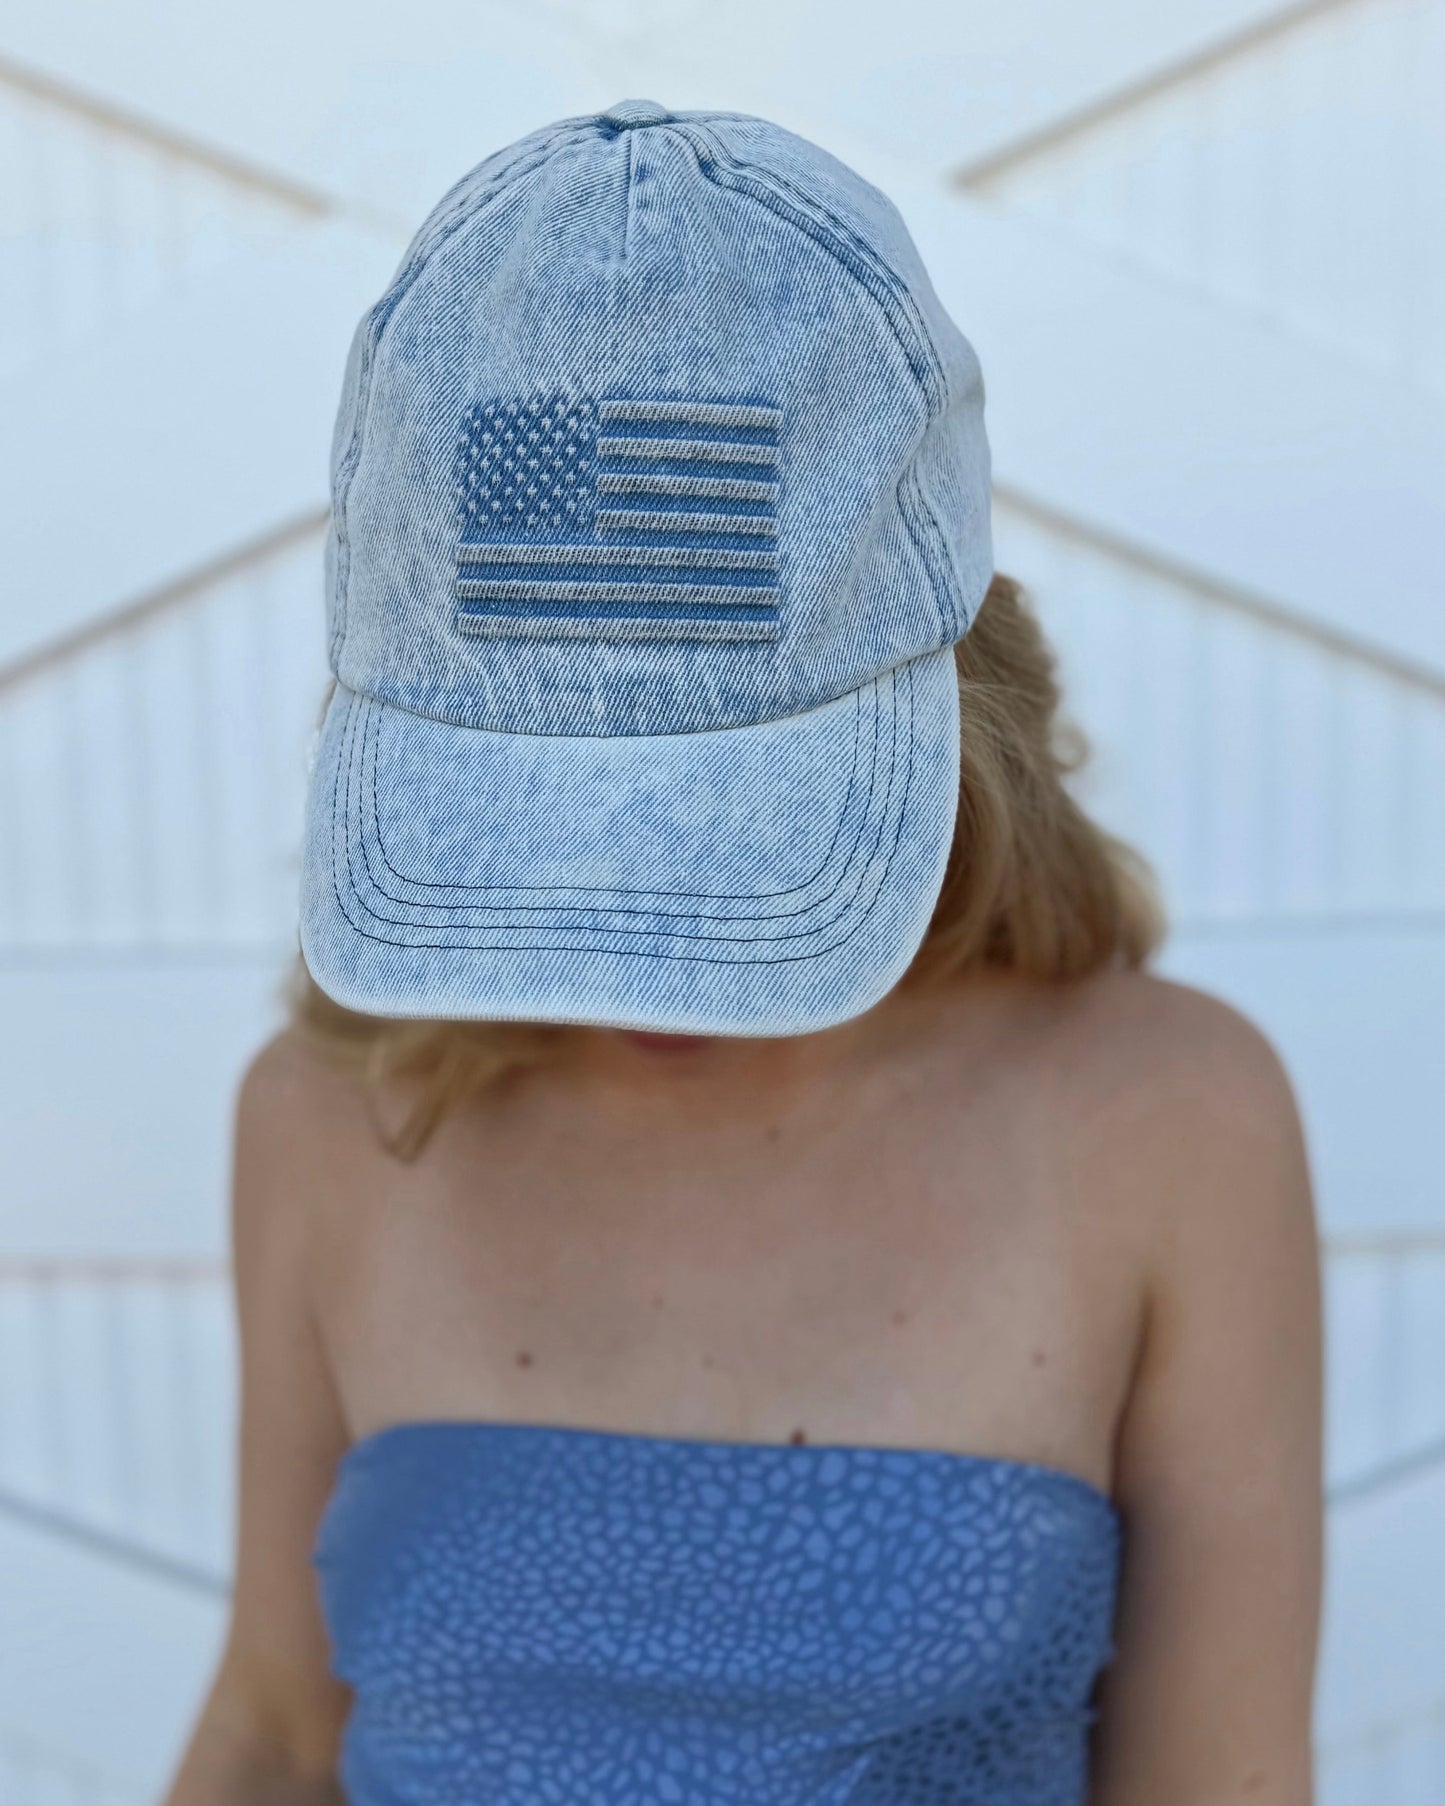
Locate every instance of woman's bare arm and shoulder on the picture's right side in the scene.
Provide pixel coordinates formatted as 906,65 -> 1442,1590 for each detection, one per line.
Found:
1058,973 -> 1322,1801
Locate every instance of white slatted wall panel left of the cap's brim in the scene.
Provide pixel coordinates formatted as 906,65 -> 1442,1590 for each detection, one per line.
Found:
0,529 -> 325,950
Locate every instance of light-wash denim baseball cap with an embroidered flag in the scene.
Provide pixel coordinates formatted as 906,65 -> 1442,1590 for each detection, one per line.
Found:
302,101 -> 992,1035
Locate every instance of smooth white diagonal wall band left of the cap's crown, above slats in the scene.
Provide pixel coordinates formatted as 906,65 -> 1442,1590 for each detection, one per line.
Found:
0,222 -> 396,674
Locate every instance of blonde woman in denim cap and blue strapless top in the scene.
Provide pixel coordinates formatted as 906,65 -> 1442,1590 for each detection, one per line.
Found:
160,101 -> 1320,1806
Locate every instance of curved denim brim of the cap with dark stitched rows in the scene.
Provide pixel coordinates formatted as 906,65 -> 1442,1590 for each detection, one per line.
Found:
302,647 -> 959,1035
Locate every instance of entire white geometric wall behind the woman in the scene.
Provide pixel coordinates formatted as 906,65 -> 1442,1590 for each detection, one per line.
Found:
0,0 -> 1445,1806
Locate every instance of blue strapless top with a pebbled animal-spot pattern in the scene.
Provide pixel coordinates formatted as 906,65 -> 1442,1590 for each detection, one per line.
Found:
314,1420 -> 1122,1806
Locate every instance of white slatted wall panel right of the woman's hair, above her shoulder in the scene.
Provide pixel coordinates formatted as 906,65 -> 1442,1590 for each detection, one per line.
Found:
995,498 -> 1445,925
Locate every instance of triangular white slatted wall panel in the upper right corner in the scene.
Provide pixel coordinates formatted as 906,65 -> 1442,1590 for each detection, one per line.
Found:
974,0 -> 1445,392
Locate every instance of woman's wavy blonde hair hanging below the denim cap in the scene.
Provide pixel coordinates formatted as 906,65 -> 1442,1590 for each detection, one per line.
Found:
287,574 -> 1163,1159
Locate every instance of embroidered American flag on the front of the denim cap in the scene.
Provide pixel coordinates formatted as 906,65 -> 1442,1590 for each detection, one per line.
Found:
457,396 -> 782,641
